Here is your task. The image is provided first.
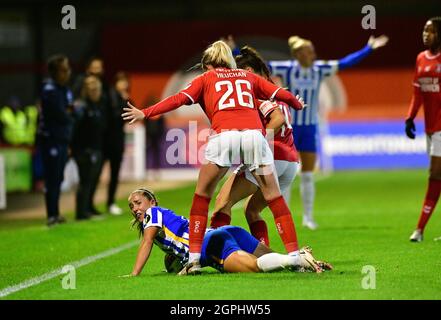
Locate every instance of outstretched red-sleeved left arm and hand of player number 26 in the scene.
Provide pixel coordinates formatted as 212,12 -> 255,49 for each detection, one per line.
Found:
121,92 -> 192,124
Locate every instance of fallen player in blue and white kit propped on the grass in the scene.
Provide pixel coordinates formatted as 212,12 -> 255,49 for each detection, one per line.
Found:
122,188 -> 332,276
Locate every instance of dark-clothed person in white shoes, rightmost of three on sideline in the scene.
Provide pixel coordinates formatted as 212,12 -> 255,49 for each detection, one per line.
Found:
100,72 -> 130,215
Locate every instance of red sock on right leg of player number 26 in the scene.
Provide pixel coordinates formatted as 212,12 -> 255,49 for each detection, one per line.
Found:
268,196 -> 299,253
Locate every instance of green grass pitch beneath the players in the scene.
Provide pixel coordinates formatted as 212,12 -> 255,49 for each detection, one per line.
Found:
0,170 -> 441,300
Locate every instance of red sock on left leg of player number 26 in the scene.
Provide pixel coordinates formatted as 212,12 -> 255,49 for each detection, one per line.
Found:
189,193 -> 211,253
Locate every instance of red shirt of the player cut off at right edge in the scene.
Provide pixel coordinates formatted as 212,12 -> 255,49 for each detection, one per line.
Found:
408,50 -> 441,134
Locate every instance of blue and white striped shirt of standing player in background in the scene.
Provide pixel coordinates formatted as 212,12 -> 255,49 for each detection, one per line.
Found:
268,60 -> 339,126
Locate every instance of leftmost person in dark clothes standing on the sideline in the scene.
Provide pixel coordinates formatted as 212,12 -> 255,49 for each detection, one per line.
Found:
37,55 -> 73,226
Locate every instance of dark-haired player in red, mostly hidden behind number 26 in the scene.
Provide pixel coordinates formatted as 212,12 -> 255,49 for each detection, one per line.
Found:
211,46 -> 300,246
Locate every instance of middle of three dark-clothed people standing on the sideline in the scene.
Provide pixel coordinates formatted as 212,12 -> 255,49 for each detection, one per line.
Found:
71,75 -> 107,220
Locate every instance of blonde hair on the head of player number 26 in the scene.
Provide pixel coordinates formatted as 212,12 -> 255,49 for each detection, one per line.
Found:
201,40 -> 236,70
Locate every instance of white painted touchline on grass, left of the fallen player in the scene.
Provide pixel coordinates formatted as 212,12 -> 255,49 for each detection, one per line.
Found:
0,241 -> 139,298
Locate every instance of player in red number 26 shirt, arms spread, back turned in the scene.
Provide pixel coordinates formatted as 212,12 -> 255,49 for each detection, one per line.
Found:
122,41 -> 310,274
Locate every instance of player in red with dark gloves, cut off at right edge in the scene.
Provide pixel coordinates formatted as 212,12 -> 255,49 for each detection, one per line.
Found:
406,17 -> 441,242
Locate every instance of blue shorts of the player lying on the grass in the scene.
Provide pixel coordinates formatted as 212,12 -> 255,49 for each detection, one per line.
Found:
201,226 -> 259,272
